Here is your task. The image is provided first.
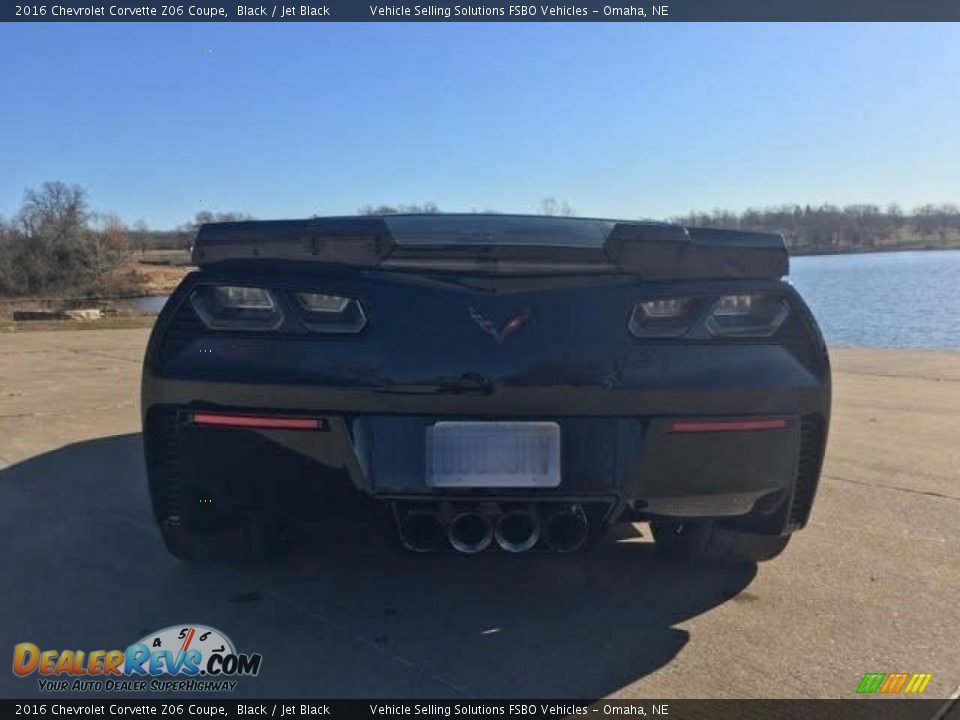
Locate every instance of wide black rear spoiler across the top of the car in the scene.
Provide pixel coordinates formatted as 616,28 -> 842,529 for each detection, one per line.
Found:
193,214 -> 789,281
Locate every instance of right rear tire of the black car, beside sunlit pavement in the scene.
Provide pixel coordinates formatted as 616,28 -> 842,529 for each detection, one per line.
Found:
654,522 -> 790,564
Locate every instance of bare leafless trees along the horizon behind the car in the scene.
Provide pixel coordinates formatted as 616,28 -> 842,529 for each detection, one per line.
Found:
0,182 -> 960,296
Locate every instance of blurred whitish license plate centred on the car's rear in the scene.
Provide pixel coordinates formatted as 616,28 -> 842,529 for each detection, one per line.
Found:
427,422 -> 560,488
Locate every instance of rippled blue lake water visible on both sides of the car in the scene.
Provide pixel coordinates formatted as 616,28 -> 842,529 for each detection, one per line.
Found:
122,250 -> 960,350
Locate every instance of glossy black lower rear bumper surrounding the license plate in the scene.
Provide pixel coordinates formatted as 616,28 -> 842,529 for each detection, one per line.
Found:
145,396 -> 826,533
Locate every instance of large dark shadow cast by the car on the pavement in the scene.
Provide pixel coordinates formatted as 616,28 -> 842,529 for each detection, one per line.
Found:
0,434 -> 756,698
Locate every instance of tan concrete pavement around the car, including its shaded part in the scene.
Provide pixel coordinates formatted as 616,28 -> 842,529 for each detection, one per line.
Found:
0,330 -> 960,698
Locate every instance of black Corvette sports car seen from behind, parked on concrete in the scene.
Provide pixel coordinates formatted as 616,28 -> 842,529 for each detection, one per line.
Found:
143,215 -> 830,561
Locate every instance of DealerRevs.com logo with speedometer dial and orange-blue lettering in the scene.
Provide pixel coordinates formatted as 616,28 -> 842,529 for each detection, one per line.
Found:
13,625 -> 263,692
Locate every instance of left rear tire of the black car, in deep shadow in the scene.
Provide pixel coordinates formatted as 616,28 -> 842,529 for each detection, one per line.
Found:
160,521 -> 289,563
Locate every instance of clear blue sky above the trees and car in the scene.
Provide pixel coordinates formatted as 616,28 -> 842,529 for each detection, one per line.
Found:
0,23 -> 960,228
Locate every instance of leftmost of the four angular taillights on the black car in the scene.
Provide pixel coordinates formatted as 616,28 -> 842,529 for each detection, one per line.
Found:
190,285 -> 283,330
